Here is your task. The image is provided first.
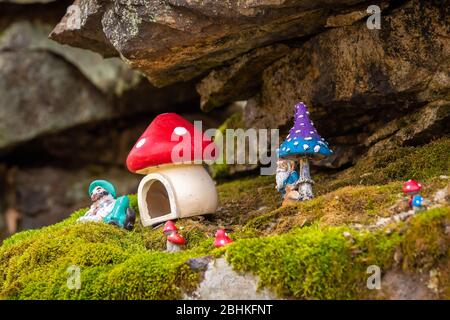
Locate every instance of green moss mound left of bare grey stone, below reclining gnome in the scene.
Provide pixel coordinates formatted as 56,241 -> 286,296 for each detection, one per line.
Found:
0,211 -> 212,299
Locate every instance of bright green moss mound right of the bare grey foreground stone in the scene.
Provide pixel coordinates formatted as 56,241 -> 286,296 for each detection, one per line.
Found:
227,207 -> 450,299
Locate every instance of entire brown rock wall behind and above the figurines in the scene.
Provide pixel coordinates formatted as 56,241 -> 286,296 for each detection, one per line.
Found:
0,0 -> 450,237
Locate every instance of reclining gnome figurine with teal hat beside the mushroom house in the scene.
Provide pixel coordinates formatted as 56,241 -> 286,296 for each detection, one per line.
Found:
77,180 -> 136,230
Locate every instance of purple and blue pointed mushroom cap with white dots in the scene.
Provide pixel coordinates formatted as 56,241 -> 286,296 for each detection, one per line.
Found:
278,102 -> 333,158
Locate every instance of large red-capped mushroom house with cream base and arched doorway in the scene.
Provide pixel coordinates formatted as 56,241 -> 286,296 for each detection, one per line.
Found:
127,113 -> 218,226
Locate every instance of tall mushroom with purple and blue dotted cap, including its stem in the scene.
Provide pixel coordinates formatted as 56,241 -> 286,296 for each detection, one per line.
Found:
278,102 -> 333,200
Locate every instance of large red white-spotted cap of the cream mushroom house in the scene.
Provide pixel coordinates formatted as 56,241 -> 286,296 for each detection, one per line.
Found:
127,113 -> 217,174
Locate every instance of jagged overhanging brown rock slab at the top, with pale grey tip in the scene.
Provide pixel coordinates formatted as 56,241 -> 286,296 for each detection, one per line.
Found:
50,0 -> 370,86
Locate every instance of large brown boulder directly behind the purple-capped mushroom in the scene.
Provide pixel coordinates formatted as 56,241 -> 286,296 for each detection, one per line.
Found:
246,0 -> 450,136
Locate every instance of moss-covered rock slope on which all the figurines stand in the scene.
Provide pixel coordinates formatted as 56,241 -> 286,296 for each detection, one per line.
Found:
0,139 -> 450,299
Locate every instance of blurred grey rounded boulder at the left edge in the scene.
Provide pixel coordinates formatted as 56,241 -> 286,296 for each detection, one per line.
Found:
0,51 -> 114,149
